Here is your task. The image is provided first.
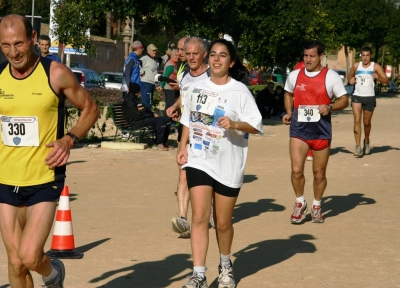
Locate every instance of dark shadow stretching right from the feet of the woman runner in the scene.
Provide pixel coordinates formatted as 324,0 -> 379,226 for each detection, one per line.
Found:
210,234 -> 317,288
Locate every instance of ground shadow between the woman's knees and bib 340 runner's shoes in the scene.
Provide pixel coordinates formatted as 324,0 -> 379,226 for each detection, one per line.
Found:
232,199 -> 285,223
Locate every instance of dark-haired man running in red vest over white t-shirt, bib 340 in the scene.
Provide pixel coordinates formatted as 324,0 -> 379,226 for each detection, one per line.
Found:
282,41 -> 348,224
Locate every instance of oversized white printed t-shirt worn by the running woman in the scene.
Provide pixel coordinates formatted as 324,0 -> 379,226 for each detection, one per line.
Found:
181,78 -> 264,188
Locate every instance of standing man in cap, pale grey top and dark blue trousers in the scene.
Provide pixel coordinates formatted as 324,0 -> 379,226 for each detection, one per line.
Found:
140,44 -> 161,111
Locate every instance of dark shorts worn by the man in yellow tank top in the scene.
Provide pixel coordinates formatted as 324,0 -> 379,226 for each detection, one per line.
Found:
0,180 -> 65,207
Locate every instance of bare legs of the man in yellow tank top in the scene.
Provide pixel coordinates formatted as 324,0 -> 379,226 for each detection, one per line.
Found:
0,202 -> 56,288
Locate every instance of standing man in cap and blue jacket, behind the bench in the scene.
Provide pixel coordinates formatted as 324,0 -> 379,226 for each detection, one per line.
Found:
121,40 -> 144,98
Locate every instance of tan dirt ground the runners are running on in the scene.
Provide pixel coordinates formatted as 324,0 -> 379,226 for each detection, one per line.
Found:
0,96 -> 400,288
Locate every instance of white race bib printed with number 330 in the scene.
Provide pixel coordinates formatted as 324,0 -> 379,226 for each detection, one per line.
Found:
1,115 -> 39,147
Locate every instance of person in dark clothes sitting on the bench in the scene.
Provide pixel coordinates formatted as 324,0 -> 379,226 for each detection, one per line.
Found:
122,82 -> 174,151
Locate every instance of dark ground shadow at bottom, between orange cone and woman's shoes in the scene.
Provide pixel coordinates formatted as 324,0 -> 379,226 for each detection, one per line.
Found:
90,254 -> 193,288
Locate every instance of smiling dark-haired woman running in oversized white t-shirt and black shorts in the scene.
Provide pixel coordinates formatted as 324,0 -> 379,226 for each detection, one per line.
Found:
177,39 -> 263,288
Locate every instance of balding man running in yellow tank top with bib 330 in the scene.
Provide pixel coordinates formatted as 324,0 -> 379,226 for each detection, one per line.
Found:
0,15 -> 99,287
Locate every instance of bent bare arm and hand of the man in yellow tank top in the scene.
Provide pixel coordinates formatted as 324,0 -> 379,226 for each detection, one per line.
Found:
45,61 -> 99,169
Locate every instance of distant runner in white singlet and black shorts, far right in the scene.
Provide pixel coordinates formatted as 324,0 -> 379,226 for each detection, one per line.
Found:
349,47 -> 389,157
